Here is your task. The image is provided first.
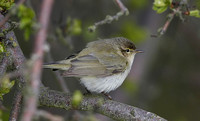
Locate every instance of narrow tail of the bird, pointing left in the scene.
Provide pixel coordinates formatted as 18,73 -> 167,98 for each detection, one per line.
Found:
43,61 -> 71,70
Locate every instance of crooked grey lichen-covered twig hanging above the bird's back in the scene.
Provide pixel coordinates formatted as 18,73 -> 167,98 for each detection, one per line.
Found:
88,0 -> 129,32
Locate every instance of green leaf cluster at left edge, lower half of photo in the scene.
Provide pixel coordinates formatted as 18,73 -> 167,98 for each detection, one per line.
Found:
0,76 -> 15,100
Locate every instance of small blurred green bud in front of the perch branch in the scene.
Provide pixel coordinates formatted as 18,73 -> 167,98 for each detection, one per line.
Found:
72,90 -> 83,107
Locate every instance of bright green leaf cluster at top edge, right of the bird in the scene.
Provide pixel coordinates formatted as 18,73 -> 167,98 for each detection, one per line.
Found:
153,0 -> 172,14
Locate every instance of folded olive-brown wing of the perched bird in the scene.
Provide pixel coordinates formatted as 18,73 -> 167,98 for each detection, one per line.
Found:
62,54 -> 126,77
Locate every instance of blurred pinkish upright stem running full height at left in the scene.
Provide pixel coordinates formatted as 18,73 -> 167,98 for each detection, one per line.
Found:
22,0 -> 54,121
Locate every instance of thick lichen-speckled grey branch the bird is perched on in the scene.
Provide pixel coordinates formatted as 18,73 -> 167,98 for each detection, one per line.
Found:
39,88 -> 166,121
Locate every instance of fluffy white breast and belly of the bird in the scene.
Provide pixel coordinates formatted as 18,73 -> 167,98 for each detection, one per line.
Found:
81,55 -> 135,93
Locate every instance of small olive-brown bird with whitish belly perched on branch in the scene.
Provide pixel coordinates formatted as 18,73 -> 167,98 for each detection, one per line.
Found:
43,37 -> 142,98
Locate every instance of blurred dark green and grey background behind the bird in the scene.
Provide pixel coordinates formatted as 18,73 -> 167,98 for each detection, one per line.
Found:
2,0 -> 200,121
